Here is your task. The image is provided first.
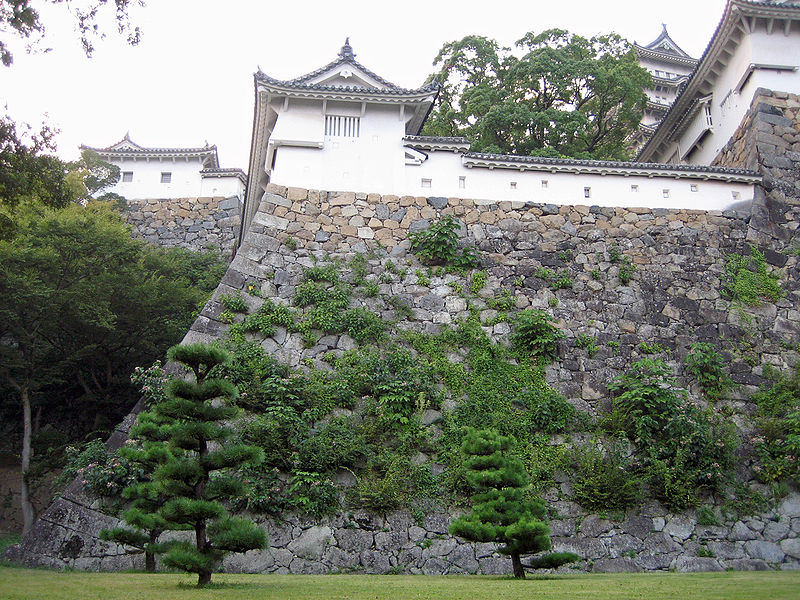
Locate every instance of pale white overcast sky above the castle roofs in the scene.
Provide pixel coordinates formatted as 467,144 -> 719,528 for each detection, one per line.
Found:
0,0 -> 725,170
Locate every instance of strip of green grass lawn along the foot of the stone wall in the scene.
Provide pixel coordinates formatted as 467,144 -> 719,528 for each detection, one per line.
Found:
0,567 -> 800,600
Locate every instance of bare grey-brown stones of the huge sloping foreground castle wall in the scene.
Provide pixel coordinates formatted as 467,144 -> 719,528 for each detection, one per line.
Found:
8,92 -> 800,573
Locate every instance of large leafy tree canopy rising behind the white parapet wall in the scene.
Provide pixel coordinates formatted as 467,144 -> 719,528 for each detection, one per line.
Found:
423,29 -> 651,160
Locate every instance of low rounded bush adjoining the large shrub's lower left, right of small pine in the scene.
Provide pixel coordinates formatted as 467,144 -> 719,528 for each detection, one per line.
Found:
572,440 -> 643,512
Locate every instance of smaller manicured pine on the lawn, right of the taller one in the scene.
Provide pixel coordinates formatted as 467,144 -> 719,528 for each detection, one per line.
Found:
450,428 -> 579,579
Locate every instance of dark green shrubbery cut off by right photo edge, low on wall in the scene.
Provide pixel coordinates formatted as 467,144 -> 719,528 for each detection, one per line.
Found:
752,363 -> 800,484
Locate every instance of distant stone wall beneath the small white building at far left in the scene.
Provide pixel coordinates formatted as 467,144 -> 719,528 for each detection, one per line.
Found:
126,196 -> 241,256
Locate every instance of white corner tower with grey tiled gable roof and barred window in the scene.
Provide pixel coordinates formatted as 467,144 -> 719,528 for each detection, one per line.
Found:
245,39 -> 439,227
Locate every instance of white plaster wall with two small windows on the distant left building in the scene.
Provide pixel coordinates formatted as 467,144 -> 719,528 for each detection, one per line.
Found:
106,158 -> 203,200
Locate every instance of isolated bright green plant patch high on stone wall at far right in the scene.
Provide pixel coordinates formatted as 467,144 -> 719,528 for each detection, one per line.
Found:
721,246 -> 784,306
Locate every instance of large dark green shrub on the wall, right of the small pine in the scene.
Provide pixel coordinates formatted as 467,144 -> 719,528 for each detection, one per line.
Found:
607,359 -> 736,509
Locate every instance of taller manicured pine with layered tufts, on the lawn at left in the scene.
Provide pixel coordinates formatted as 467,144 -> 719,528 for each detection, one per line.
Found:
148,344 -> 266,586
